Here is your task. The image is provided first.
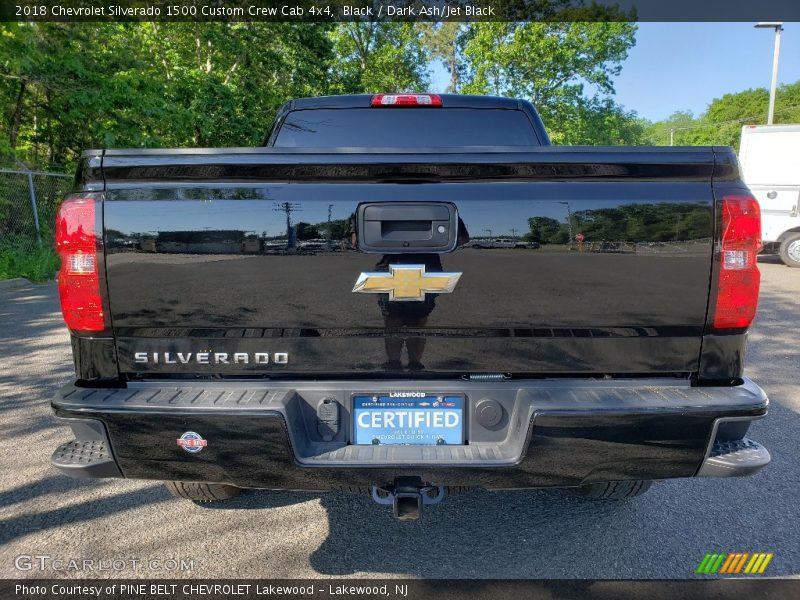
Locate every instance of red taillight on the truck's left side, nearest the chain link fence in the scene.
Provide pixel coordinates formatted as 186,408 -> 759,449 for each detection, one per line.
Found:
56,196 -> 106,332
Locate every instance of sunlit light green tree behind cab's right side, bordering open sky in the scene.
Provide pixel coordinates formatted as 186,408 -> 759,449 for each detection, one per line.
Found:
461,22 -> 643,144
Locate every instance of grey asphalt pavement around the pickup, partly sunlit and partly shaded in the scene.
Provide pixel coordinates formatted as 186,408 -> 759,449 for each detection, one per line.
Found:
0,257 -> 800,579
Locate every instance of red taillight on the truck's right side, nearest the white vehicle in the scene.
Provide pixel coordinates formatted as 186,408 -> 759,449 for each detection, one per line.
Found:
714,196 -> 761,329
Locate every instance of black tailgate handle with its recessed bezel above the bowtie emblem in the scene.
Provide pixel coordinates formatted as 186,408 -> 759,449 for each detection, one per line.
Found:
357,202 -> 458,254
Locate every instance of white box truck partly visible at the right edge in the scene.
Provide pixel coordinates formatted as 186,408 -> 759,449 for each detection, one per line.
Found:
739,125 -> 800,267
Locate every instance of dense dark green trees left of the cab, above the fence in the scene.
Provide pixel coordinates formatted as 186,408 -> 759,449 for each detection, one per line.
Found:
0,23 -> 332,168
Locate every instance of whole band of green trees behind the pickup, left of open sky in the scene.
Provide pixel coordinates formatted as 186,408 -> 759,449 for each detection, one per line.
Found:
0,22 -> 656,169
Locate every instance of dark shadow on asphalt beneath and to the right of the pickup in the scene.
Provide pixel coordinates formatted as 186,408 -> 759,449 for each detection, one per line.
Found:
191,398 -> 800,578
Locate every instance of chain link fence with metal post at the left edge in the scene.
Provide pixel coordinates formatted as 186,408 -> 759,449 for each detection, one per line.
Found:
0,169 -> 72,251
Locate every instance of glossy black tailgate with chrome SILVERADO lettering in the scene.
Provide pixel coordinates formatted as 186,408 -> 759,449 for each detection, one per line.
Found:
101,148 -> 715,377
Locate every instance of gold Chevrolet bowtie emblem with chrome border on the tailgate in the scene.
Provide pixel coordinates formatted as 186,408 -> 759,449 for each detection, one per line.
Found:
353,265 -> 461,302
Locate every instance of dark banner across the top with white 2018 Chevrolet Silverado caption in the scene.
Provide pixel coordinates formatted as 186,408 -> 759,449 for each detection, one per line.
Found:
0,0 -> 800,23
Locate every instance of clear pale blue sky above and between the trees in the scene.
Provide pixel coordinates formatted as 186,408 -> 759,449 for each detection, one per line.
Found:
432,23 -> 800,121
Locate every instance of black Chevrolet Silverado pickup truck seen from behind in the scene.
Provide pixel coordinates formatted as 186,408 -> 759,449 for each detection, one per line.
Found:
52,94 -> 770,519
